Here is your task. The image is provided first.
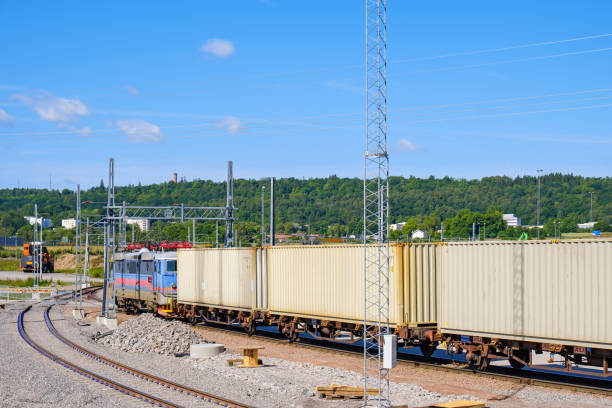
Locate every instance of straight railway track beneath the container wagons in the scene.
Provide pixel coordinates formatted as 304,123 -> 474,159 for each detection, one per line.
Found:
195,323 -> 612,396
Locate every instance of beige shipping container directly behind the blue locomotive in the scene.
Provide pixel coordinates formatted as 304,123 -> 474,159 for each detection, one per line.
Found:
177,248 -> 256,310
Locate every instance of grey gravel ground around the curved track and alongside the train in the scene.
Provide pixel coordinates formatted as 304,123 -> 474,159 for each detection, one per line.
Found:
0,296 -> 612,408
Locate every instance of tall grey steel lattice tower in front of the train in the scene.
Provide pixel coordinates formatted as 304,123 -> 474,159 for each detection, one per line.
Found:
363,0 -> 391,407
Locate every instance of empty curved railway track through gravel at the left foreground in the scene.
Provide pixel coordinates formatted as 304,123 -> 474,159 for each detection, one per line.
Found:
17,290 -> 250,408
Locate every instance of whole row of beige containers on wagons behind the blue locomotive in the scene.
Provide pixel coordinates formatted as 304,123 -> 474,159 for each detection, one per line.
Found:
112,239 -> 612,377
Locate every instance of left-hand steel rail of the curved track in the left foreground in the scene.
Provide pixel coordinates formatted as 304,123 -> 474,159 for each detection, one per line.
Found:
17,305 -> 180,408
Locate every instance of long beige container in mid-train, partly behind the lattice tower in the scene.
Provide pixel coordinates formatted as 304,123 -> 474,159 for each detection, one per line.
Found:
266,245 -> 404,325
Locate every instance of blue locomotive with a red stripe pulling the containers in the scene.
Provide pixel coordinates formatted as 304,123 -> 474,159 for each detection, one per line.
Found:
112,248 -> 176,314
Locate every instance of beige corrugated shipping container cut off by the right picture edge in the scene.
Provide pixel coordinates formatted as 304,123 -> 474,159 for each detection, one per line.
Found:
438,239 -> 612,349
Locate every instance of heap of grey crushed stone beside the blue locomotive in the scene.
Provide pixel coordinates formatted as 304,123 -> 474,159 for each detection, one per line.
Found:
95,313 -> 206,356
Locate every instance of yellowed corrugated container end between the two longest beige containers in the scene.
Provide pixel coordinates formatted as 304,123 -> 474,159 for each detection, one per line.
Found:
403,243 -> 439,326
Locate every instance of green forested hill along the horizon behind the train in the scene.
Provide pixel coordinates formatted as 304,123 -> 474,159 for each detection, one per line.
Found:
0,174 -> 612,234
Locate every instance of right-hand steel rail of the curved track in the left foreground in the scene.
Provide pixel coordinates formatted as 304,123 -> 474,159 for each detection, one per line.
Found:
44,305 -> 251,408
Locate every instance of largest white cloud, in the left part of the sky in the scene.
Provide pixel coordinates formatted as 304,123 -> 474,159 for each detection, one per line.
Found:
11,91 -> 89,122
